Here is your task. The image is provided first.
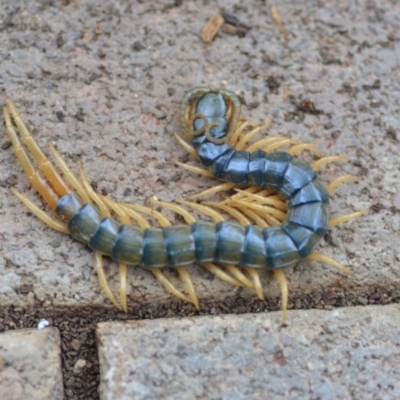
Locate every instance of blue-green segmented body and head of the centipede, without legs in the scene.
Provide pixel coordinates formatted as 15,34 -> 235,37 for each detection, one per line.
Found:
50,88 -> 329,269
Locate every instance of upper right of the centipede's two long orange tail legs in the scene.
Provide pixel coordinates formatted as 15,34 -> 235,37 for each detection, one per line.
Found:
4,99 -> 71,196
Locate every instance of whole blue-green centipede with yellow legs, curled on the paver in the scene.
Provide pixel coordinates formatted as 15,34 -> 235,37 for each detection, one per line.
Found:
4,87 -> 367,323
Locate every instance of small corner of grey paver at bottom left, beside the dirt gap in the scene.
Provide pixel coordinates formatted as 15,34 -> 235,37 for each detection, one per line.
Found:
0,328 -> 64,400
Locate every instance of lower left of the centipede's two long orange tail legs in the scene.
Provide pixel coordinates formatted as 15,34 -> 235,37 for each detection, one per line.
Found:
4,107 -> 59,210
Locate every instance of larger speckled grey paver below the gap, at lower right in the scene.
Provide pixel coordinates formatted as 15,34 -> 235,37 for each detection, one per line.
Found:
97,305 -> 400,400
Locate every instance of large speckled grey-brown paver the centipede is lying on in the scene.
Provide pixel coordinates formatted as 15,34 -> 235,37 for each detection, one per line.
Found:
0,0 -> 400,309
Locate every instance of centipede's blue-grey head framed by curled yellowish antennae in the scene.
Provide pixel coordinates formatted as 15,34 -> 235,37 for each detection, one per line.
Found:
181,86 -> 241,143
